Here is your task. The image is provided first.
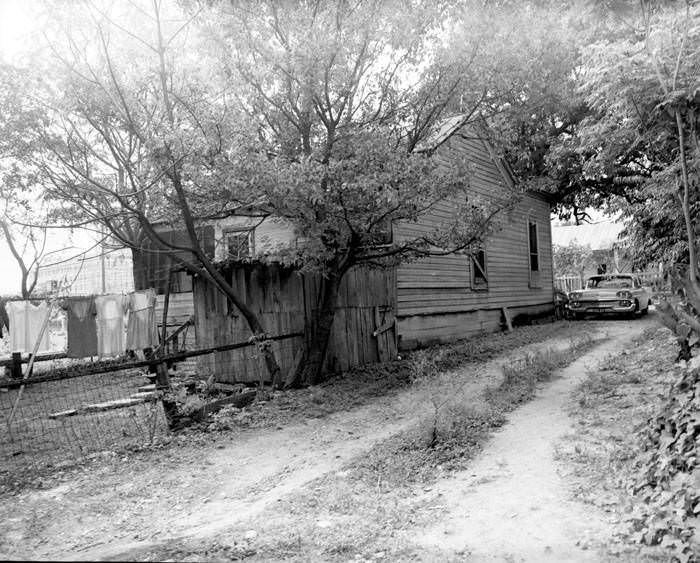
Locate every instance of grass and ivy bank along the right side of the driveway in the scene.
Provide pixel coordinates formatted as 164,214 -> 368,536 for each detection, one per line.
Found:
557,327 -> 697,561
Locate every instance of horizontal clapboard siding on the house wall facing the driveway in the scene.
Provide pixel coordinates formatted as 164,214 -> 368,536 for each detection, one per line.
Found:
395,131 -> 553,348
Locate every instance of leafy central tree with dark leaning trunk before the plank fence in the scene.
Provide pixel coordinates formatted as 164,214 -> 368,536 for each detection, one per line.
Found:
197,0 -> 510,386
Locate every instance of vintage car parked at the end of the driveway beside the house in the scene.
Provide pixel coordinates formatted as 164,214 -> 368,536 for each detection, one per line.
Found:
568,274 -> 651,318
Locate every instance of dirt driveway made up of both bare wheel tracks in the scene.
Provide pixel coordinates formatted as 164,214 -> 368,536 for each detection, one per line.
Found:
0,321 -> 649,561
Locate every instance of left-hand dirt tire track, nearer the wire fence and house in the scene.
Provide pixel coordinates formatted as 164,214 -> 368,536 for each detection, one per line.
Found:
3,328 -> 608,560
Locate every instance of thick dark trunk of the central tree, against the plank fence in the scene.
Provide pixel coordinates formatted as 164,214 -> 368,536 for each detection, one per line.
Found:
285,272 -> 343,387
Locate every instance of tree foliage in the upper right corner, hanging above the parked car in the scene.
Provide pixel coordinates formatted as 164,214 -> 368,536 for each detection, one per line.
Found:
546,2 -> 700,246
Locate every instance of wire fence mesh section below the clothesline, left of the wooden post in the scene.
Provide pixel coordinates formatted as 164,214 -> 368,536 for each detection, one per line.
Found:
0,362 -> 167,465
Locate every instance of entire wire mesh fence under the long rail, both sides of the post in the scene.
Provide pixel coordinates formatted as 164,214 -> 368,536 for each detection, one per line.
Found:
0,337 -> 301,470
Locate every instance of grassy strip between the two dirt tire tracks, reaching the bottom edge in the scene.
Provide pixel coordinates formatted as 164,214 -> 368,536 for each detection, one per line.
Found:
196,336 -> 594,561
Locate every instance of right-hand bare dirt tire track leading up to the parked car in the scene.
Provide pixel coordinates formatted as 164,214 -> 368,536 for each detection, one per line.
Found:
410,321 -> 650,562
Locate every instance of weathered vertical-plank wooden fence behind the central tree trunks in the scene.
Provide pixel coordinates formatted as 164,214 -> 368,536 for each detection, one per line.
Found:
193,264 -> 397,383
